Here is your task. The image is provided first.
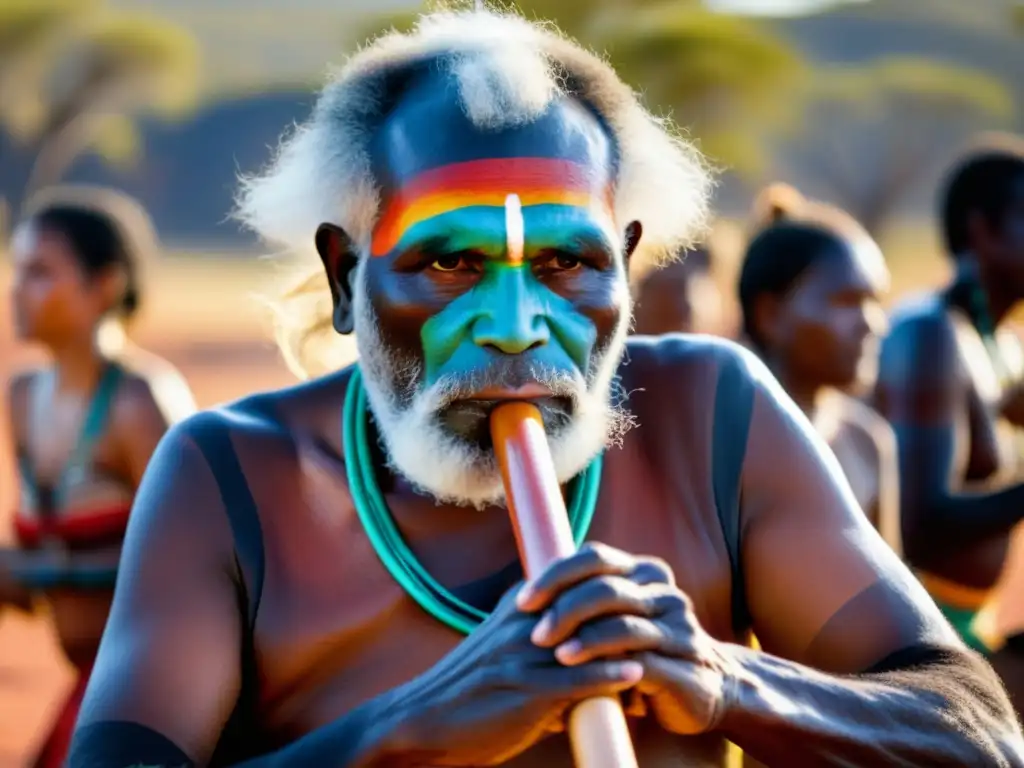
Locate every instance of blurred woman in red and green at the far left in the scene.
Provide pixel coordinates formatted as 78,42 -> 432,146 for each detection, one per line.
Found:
0,187 -> 195,768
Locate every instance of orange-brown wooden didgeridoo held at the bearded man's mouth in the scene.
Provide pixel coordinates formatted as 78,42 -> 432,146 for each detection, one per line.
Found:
490,402 -> 637,768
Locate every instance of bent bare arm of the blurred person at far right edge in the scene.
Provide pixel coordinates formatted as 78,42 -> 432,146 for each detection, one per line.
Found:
876,314 -> 1024,566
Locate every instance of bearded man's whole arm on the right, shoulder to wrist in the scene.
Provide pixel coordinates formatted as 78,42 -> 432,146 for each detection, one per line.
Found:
722,354 -> 1024,768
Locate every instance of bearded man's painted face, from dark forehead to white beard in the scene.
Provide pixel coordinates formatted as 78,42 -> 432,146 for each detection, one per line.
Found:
355,82 -> 629,505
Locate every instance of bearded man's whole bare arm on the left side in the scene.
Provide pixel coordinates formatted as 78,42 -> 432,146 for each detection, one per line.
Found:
69,414 -> 405,768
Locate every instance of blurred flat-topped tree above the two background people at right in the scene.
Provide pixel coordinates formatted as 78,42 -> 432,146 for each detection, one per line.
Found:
776,57 -> 1014,234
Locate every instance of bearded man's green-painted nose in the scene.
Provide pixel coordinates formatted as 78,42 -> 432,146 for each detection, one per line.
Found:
473,267 -> 551,354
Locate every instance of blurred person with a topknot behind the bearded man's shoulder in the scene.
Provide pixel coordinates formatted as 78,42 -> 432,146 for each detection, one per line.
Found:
738,184 -> 902,553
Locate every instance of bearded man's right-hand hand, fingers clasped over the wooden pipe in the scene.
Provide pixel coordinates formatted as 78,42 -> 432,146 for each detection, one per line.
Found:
517,544 -> 732,734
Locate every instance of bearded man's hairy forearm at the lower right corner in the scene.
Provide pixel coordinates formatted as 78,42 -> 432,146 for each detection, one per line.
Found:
720,647 -> 1024,768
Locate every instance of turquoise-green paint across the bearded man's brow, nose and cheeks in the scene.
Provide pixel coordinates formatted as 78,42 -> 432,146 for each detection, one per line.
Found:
403,191 -> 625,385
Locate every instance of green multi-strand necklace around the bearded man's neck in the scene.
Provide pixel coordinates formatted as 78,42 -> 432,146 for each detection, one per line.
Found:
341,367 -> 602,635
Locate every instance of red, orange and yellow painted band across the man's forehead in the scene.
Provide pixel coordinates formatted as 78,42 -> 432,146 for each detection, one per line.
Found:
370,158 -> 611,256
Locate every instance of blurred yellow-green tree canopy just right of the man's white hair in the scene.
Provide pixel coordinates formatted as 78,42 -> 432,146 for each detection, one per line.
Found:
362,0 -> 808,173
